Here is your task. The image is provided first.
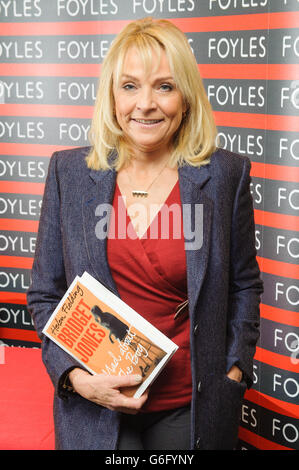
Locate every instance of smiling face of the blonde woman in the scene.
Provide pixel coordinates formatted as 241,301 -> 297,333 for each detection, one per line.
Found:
113,47 -> 185,155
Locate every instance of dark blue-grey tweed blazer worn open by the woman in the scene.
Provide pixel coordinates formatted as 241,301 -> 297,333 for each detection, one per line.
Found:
28,147 -> 263,450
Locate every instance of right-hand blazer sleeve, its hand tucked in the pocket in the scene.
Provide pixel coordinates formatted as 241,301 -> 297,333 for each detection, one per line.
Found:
227,157 -> 263,388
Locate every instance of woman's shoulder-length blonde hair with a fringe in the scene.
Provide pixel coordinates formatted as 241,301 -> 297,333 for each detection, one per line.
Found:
86,18 -> 217,170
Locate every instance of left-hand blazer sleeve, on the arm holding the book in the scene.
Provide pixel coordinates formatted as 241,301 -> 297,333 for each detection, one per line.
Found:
27,152 -> 80,398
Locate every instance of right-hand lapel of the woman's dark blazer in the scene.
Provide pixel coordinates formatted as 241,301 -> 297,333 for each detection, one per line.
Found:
179,165 -> 213,317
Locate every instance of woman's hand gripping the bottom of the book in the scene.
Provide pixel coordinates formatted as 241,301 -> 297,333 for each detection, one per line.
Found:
69,368 -> 148,414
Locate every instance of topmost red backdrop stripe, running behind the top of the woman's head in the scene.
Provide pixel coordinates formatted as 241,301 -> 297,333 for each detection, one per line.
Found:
1,12 -> 299,36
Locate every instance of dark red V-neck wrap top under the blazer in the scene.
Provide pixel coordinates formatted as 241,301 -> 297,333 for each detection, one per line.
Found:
107,182 -> 192,412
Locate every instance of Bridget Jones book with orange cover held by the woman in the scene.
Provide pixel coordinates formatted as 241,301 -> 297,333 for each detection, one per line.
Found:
43,271 -> 178,398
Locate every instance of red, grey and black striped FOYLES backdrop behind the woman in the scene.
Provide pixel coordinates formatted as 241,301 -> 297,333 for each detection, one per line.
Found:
0,0 -> 299,449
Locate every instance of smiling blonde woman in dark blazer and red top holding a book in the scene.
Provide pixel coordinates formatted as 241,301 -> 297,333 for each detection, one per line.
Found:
28,18 -> 262,450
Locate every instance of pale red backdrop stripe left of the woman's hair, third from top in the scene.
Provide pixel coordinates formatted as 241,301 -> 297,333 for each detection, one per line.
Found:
0,103 -> 93,119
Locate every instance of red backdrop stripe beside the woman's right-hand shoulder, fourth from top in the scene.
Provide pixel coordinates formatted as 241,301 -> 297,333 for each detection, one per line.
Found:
250,162 -> 299,183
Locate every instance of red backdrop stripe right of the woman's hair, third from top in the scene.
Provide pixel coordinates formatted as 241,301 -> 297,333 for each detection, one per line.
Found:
214,111 -> 299,132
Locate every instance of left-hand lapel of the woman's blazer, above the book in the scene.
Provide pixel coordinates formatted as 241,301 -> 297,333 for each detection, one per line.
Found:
82,166 -> 119,296
